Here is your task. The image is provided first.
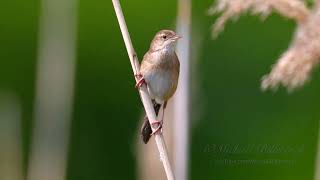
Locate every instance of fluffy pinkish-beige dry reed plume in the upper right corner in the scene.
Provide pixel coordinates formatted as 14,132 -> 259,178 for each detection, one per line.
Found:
209,0 -> 320,91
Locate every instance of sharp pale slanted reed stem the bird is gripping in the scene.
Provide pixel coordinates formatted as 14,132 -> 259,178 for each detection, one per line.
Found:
112,0 -> 175,180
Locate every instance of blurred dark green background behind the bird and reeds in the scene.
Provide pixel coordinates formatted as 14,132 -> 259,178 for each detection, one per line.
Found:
0,0 -> 320,180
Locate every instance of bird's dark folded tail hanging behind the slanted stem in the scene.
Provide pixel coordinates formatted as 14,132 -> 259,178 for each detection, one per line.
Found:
141,100 -> 161,144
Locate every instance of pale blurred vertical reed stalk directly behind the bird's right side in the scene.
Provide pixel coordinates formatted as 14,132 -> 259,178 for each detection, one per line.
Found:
174,0 -> 192,180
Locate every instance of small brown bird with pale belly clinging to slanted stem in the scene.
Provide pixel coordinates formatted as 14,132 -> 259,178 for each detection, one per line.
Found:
136,30 -> 181,144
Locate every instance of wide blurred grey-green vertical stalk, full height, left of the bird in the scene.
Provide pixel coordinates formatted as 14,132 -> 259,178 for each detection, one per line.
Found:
27,0 -> 77,180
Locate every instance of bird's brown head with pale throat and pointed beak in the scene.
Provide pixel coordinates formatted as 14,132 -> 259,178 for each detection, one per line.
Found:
150,30 -> 181,52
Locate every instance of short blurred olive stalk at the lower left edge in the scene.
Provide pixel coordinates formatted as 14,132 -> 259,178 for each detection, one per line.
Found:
0,93 -> 24,180
